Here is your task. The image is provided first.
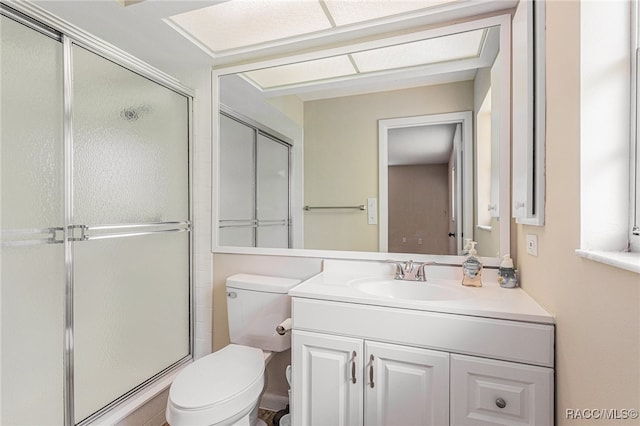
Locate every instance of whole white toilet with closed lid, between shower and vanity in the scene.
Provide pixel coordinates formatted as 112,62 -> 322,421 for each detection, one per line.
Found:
166,274 -> 300,426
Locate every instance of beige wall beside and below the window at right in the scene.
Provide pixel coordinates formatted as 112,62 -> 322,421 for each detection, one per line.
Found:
517,1 -> 640,425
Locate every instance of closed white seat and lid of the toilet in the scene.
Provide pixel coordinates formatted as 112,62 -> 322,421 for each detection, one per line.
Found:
167,344 -> 265,424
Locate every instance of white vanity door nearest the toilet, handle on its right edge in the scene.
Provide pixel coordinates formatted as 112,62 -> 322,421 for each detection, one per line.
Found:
290,330 -> 363,426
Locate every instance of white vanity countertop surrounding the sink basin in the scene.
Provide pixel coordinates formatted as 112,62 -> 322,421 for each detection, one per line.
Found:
289,260 -> 554,324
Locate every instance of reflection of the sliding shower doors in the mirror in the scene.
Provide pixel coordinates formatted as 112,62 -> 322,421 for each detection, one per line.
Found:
218,113 -> 291,248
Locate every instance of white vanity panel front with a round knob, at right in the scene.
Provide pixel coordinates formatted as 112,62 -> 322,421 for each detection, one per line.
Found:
451,355 -> 553,426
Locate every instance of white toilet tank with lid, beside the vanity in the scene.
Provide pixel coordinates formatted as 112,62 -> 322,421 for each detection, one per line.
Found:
227,274 -> 300,352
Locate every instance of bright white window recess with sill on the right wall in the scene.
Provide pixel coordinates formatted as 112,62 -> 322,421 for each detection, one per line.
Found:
576,0 -> 640,273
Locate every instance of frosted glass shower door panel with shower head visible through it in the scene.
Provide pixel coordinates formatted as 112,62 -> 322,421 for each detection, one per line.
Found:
72,46 -> 190,422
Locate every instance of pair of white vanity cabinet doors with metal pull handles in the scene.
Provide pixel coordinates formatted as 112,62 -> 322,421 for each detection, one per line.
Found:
292,331 -> 449,426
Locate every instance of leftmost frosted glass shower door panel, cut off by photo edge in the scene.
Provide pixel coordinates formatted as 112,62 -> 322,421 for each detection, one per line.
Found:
0,16 -> 65,425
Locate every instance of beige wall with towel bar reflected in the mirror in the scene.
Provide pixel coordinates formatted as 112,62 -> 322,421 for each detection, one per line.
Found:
304,81 -> 473,251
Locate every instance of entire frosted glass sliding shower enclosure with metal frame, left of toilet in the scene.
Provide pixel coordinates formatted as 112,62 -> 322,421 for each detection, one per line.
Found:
0,6 -> 193,425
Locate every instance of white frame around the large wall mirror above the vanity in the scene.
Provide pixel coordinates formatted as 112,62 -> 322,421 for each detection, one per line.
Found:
211,12 -> 511,267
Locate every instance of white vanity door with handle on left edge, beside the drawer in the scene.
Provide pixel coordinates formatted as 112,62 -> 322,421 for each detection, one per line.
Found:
364,342 -> 449,426
